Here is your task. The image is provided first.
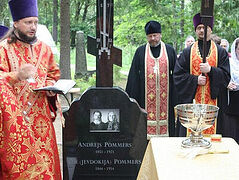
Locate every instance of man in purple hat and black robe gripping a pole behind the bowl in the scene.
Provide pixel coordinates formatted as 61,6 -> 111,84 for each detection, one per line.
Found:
174,14 -> 230,136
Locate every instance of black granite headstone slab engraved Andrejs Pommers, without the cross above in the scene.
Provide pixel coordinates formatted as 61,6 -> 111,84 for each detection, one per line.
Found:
63,87 -> 147,180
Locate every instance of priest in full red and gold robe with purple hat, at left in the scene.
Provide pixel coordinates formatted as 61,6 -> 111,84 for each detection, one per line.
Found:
0,0 -> 61,180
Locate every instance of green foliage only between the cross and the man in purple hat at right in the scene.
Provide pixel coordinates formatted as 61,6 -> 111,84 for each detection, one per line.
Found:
114,0 -> 198,50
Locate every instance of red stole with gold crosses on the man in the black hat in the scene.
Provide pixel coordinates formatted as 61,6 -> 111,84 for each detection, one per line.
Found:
145,41 -> 169,137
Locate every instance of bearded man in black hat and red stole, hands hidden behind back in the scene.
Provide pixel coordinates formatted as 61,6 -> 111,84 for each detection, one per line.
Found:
126,21 -> 177,138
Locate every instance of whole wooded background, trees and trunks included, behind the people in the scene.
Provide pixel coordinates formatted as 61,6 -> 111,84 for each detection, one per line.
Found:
0,0 -> 239,91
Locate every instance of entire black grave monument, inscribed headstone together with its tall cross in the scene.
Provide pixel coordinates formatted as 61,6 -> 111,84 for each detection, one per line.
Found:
63,0 -> 147,180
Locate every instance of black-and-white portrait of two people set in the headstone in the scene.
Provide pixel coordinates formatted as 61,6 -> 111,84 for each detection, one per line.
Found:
90,109 -> 120,132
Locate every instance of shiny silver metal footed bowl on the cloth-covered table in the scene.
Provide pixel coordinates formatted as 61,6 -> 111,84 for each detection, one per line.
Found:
175,104 -> 219,148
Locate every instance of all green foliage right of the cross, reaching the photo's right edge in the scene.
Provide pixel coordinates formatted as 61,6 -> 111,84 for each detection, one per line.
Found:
115,0 -> 239,52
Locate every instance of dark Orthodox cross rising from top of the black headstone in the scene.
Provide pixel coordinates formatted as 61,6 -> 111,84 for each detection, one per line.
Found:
87,0 -> 122,87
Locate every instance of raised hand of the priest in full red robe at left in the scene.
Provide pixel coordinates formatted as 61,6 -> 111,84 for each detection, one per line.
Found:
17,64 -> 36,81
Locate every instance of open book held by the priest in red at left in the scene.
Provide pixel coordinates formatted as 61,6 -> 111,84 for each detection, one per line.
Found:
34,79 -> 76,94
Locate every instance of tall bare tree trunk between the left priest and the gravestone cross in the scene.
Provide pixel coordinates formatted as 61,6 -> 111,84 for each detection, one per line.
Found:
60,0 -> 71,79
